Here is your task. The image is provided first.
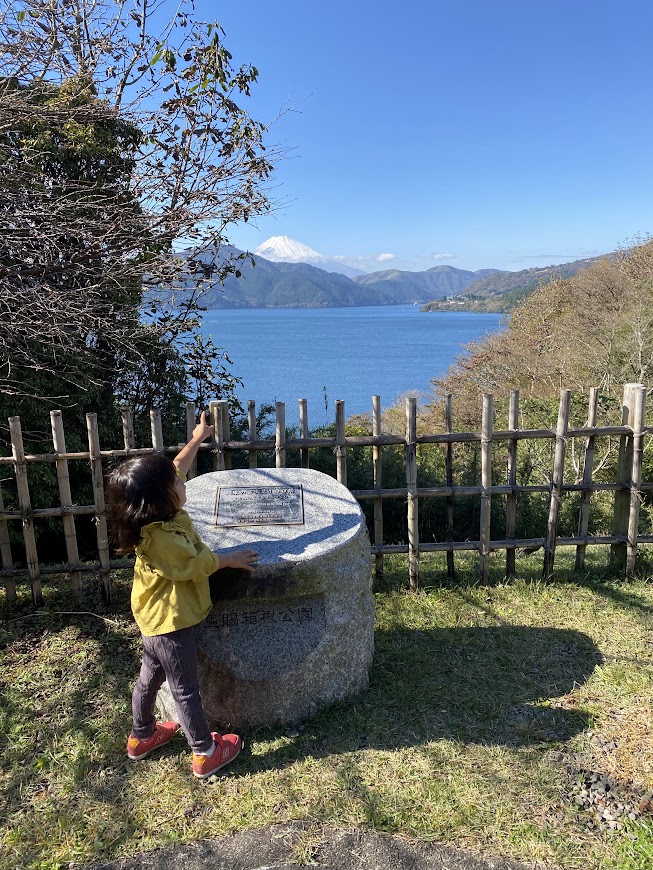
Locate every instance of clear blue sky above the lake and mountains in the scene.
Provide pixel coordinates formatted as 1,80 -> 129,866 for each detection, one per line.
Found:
197,0 -> 653,271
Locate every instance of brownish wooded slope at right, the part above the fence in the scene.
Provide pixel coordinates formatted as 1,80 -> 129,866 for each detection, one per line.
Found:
428,241 -> 653,416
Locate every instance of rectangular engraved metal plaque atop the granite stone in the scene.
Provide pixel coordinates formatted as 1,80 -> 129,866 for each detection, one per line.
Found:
214,484 -> 304,526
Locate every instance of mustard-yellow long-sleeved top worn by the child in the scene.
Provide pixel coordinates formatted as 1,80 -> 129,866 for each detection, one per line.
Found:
131,510 -> 219,637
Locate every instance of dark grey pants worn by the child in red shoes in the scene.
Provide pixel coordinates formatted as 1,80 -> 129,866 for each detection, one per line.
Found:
132,626 -> 213,752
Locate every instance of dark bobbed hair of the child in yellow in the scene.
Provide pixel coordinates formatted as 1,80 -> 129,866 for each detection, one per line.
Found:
107,453 -> 178,553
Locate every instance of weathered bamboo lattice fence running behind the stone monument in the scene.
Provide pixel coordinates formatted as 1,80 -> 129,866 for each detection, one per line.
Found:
0,384 -> 653,604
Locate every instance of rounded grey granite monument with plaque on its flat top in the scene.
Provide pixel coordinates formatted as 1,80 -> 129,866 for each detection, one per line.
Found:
159,469 -> 374,726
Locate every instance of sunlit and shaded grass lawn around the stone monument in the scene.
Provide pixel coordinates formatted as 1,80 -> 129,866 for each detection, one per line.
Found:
0,552 -> 653,870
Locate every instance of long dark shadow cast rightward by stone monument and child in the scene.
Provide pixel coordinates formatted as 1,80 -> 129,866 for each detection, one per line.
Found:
247,626 -> 603,767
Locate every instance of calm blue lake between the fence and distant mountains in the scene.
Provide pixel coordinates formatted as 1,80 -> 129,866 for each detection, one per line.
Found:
202,305 -> 502,427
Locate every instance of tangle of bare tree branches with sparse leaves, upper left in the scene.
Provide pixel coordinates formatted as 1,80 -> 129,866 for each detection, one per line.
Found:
0,0 -> 279,404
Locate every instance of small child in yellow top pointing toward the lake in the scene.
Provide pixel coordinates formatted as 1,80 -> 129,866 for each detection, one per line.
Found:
107,413 -> 258,779
